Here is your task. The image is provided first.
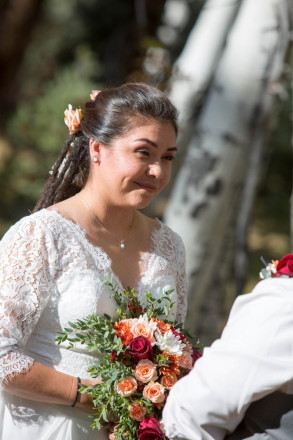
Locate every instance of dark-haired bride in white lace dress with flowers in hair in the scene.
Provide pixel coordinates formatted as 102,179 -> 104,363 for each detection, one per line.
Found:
0,83 -> 186,440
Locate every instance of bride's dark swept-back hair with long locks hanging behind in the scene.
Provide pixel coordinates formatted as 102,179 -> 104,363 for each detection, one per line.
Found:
34,83 -> 178,212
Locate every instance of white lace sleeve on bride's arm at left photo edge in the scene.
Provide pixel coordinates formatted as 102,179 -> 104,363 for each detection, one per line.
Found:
0,217 -> 55,389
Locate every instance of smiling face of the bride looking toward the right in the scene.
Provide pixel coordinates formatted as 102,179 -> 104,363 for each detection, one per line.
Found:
91,119 -> 176,209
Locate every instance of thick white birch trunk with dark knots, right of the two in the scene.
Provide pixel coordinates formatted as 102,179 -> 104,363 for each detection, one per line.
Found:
165,0 -> 292,343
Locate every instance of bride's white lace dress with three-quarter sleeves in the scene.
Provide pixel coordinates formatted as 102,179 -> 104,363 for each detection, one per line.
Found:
0,209 -> 186,440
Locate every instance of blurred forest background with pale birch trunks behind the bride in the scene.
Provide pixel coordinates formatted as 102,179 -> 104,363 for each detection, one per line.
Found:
0,0 -> 293,344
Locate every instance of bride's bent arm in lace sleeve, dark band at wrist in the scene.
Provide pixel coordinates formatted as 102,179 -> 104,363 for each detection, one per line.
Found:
0,217 -> 98,409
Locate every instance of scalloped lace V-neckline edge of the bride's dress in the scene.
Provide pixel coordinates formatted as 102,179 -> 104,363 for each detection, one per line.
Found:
39,208 -> 163,292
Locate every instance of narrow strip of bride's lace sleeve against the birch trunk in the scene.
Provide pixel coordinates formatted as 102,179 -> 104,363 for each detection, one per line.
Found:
176,235 -> 187,323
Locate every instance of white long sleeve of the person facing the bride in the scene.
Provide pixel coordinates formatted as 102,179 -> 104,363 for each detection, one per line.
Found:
163,278 -> 293,440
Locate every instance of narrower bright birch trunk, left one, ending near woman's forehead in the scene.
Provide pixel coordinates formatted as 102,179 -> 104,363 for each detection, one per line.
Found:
166,0 -> 242,131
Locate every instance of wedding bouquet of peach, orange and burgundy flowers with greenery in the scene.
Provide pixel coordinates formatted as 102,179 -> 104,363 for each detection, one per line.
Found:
57,280 -> 202,440
